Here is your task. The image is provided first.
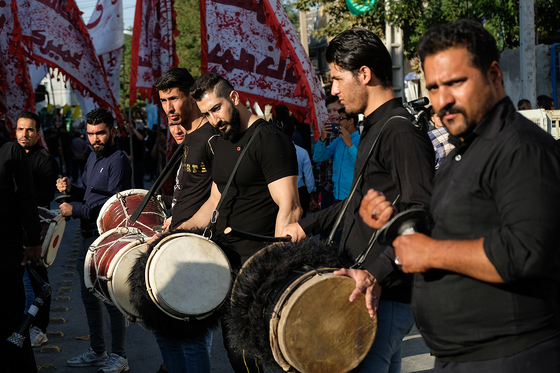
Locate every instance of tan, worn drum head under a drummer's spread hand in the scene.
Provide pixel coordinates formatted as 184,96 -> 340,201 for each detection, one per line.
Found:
270,273 -> 377,373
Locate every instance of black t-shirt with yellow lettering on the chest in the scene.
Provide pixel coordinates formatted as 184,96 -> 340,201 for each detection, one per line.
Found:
170,122 -> 219,229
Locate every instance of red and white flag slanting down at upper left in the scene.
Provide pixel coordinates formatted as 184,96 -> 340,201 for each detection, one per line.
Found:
18,0 -> 120,120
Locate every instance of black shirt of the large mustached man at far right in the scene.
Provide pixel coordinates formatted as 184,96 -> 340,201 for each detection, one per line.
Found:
413,98 -> 560,361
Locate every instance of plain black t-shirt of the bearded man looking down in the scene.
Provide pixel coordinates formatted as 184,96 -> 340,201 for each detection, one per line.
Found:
212,119 -> 298,256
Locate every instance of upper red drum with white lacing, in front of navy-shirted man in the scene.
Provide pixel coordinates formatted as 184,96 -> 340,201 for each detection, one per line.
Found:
97,189 -> 166,236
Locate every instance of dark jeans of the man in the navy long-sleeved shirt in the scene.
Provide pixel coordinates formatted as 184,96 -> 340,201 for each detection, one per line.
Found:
76,237 -> 126,356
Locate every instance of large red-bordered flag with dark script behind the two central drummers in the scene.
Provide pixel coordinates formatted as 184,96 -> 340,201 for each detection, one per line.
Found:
200,0 -> 327,138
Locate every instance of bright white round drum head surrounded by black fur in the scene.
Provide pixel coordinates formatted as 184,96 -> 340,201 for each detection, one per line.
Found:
146,233 -> 231,319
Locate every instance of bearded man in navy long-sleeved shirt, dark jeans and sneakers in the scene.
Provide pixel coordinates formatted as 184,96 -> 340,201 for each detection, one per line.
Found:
56,108 -> 132,373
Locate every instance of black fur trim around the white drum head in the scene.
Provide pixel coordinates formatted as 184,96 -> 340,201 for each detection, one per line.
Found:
128,229 -> 236,342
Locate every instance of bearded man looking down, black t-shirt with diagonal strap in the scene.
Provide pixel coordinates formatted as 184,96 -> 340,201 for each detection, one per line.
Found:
180,73 -> 302,372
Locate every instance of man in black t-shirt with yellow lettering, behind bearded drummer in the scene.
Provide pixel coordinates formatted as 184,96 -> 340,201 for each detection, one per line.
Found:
150,68 -> 218,373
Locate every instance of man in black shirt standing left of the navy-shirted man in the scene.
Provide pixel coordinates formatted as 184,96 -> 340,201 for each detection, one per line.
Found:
16,111 -> 58,347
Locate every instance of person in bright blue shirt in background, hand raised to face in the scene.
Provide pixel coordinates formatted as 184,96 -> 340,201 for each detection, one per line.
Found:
313,108 -> 360,202
